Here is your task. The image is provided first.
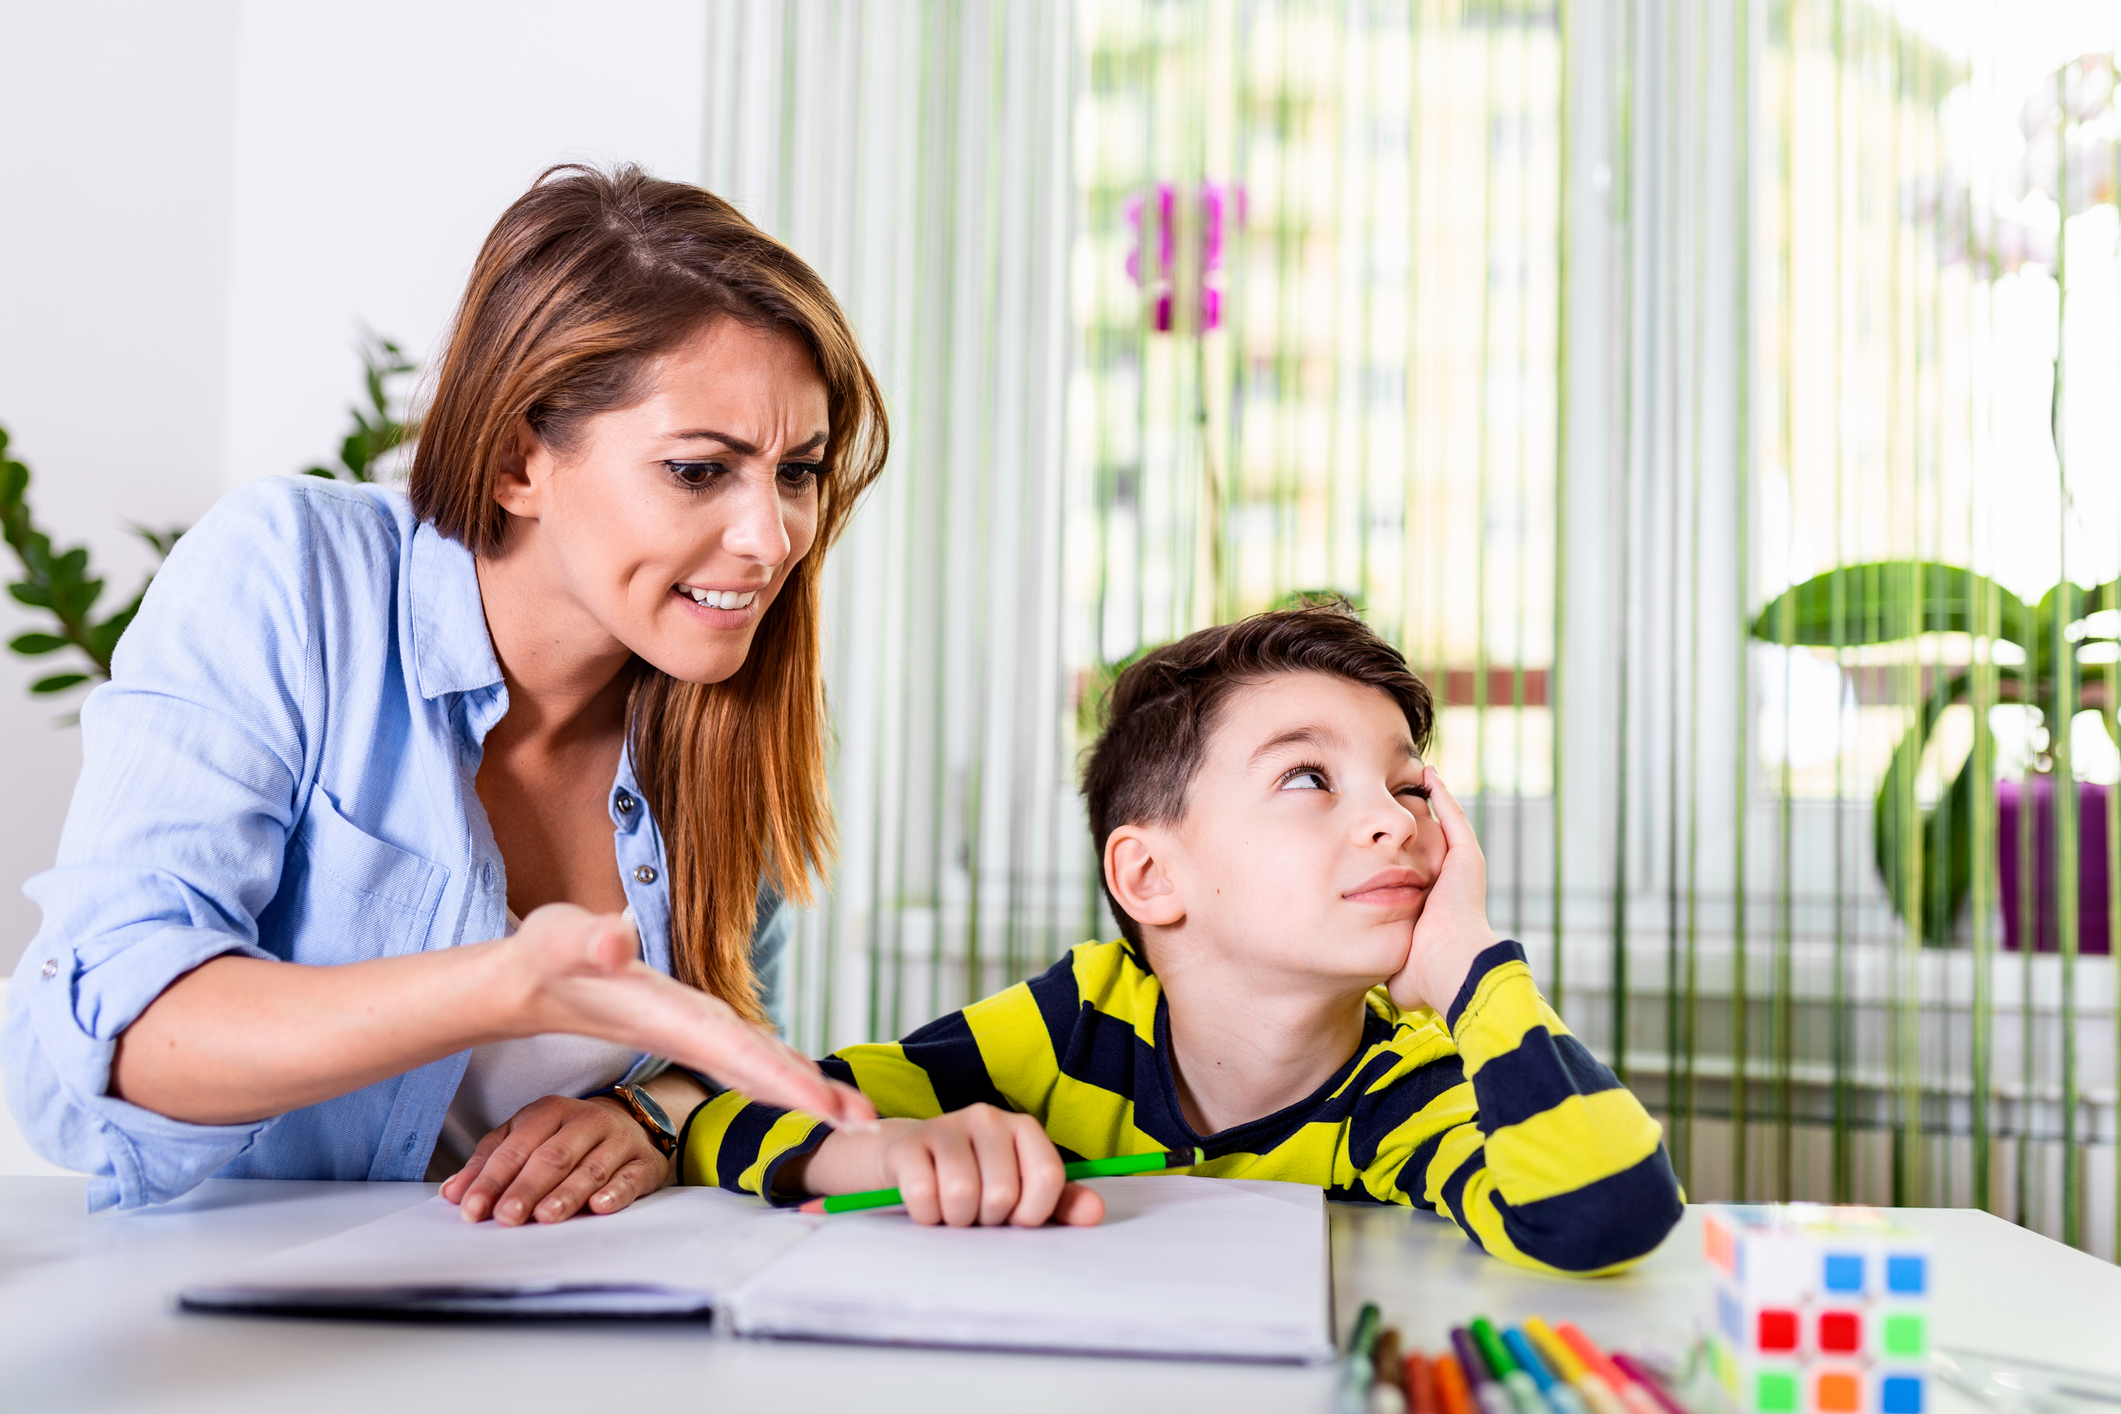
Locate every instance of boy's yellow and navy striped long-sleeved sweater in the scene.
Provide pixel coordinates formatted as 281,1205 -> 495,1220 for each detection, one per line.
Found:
683,941 -> 1682,1274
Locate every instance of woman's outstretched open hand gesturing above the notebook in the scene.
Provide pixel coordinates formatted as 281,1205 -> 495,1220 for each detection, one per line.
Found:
500,903 -> 876,1138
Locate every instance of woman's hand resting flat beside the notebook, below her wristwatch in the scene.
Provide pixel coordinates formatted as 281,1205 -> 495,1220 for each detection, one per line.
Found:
441,1094 -> 672,1227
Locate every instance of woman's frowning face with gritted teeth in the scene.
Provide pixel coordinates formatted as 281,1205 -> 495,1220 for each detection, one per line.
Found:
496,318 -> 827,683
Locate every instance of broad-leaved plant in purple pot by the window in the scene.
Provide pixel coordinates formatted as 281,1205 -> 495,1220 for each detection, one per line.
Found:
1752,560 -> 2121,952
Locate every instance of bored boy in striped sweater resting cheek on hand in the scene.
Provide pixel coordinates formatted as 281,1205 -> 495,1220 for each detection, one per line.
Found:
683,604 -> 1680,1274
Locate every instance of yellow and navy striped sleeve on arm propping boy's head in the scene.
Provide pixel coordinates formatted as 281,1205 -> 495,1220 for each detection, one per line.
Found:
1349,943 -> 1682,1276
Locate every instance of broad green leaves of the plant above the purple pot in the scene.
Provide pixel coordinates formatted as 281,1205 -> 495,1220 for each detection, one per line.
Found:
1752,560 -> 2121,945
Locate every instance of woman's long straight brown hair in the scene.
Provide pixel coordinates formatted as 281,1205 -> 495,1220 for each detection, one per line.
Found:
407,163 -> 891,1022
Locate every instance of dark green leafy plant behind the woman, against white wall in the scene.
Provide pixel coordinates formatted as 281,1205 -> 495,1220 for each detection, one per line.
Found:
0,331 -> 418,695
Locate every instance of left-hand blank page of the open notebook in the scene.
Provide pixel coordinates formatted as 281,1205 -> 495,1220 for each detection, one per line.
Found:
180,1187 -> 823,1316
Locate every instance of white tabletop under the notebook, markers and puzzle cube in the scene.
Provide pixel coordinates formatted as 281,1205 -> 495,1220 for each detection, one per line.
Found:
0,1179 -> 2121,1414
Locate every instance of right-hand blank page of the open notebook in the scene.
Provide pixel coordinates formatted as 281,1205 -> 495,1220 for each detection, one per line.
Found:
730,1177 -> 1332,1361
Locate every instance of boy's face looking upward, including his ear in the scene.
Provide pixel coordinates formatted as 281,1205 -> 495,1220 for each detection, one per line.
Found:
1107,672 -> 1444,986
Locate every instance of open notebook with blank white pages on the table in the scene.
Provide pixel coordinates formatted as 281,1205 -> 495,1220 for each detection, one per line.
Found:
190,1177 -> 1332,1361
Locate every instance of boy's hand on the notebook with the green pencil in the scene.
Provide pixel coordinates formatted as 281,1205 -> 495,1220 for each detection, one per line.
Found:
793,1104 -> 1105,1227
